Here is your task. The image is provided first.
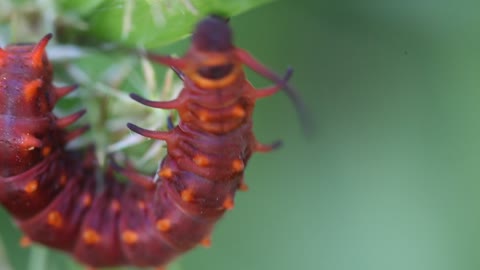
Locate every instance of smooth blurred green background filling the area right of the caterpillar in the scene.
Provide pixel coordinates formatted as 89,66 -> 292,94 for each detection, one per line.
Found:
0,0 -> 480,270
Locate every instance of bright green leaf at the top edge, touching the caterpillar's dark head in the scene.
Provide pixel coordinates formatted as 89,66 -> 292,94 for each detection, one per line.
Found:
75,0 -> 273,48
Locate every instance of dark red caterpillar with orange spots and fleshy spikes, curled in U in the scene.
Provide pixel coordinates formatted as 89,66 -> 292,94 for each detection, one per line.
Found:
0,16 -> 306,268
